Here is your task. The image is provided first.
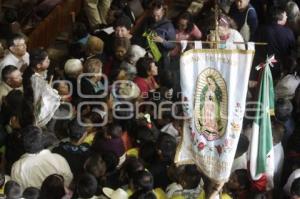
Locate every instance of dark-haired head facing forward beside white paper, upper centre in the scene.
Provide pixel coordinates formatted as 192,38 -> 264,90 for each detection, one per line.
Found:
114,15 -> 132,38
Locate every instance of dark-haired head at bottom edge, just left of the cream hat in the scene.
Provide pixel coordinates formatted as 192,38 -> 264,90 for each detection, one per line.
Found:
77,173 -> 98,198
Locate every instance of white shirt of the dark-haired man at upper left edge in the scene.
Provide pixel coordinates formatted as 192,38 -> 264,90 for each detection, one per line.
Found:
0,52 -> 29,79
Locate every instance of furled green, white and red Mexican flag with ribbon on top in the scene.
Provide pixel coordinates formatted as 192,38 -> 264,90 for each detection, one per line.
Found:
250,57 -> 275,191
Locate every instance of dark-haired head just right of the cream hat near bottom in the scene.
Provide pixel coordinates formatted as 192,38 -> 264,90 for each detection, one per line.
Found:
131,170 -> 154,191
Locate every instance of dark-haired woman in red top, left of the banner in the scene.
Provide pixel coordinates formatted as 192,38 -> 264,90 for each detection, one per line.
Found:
133,57 -> 159,97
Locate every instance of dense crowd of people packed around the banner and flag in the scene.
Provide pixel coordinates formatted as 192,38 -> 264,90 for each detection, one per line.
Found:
0,0 -> 300,199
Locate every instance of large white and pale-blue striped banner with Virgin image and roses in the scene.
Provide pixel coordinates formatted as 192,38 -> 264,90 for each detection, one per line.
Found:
175,43 -> 254,182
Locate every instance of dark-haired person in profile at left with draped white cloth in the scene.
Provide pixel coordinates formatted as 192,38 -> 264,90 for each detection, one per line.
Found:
23,48 -> 60,127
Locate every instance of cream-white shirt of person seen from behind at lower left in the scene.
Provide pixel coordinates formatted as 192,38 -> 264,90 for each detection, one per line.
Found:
11,149 -> 73,190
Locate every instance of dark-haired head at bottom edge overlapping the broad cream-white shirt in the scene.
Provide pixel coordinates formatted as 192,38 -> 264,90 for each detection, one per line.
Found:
40,174 -> 66,199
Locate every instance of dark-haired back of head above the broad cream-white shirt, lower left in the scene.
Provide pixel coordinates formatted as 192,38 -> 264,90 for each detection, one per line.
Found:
21,126 -> 44,154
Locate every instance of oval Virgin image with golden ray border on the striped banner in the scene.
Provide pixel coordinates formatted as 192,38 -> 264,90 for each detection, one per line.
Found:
194,68 -> 228,141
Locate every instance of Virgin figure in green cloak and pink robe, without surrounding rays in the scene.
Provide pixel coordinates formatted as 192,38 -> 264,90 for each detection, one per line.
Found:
198,76 -> 224,137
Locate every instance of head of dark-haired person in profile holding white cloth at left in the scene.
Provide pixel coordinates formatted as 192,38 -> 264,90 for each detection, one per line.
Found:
30,48 -> 50,73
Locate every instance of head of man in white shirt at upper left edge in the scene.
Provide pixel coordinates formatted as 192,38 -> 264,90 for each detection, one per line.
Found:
7,34 -> 27,57
